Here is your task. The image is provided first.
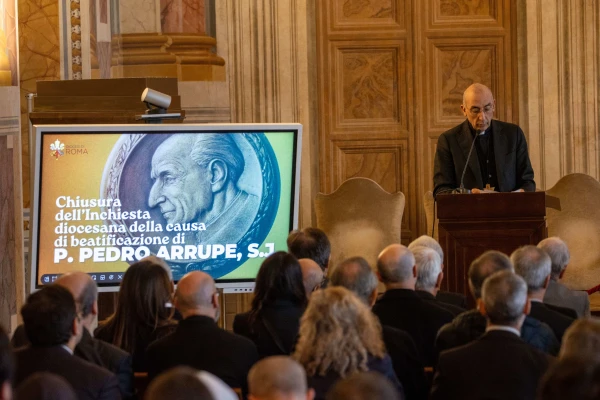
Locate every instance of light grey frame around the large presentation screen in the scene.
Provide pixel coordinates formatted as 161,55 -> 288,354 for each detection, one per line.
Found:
29,123 -> 302,293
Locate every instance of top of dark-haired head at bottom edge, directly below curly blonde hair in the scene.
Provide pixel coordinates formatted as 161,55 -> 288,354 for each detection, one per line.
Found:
327,372 -> 401,400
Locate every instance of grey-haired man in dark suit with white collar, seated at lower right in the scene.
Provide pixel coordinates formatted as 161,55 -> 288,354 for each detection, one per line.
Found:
430,270 -> 550,400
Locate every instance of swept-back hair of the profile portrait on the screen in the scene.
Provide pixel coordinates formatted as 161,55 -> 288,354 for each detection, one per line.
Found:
190,133 -> 245,183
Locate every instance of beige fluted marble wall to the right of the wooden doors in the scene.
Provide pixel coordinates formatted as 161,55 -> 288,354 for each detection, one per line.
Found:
517,0 -> 600,189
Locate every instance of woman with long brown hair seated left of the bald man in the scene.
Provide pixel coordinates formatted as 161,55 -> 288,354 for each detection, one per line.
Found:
95,259 -> 176,372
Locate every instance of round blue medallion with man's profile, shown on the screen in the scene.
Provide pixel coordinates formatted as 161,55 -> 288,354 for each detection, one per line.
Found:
101,133 -> 281,280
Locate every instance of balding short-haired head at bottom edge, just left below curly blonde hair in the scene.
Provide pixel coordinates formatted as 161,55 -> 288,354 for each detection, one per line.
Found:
248,356 -> 315,400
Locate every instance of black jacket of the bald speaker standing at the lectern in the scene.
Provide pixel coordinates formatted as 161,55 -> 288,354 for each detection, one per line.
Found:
433,120 -> 535,196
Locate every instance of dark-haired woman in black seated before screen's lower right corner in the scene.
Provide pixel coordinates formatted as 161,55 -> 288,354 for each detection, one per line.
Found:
233,251 -> 307,358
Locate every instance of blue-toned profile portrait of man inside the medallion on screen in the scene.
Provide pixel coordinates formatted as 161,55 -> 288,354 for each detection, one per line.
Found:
148,133 -> 261,244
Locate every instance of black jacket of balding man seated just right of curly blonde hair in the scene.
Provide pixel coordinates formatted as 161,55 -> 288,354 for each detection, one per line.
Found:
373,289 -> 453,366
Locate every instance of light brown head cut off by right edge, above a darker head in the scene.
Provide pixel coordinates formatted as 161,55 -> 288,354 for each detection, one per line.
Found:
560,318 -> 600,361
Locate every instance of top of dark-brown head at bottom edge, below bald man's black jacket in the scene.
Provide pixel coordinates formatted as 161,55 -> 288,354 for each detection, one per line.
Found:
144,367 -> 217,400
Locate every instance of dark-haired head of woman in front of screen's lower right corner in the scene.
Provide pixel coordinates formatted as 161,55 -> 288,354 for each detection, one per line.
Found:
252,251 -> 306,316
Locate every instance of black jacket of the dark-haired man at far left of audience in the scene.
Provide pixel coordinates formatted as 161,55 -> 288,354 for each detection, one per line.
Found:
15,346 -> 121,400
